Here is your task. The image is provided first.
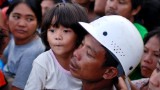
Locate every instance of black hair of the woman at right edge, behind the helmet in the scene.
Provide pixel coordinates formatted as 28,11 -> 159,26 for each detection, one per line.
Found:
144,27 -> 160,45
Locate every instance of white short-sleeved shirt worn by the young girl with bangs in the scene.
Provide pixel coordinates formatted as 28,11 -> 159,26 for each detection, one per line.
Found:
25,50 -> 82,90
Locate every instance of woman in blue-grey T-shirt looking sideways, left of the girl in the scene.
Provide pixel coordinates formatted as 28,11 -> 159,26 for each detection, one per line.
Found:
3,0 -> 45,90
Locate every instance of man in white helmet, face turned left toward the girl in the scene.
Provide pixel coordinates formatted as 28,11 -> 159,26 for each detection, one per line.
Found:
70,15 -> 143,90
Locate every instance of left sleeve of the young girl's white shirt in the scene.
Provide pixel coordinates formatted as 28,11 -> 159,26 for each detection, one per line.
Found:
25,59 -> 46,90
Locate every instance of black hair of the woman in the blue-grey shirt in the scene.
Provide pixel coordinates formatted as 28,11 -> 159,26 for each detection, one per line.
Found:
6,0 -> 42,26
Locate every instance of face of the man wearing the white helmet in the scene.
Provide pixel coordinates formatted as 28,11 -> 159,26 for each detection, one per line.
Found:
70,35 -> 106,81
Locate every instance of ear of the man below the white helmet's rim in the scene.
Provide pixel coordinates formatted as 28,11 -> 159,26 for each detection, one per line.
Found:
103,67 -> 118,79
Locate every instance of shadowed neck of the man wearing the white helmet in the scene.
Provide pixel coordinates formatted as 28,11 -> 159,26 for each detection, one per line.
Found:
82,79 -> 113,90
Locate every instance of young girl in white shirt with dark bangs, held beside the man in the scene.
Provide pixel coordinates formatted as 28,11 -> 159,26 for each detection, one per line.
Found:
25,3 -> 88,90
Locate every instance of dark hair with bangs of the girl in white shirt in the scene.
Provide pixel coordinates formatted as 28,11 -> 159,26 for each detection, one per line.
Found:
41,3 -> 88,50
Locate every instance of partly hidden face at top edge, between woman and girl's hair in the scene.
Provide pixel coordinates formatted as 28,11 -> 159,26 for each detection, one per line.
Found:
41,0 -> 55,17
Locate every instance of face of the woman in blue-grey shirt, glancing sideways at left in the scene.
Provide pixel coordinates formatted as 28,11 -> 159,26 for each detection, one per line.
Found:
8,3 -> 38,41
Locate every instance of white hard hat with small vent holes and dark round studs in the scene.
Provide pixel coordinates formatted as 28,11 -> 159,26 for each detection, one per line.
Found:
79,15 -> 144,75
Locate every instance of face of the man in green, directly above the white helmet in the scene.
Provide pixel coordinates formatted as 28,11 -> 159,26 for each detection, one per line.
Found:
105,0 -> 133,20
